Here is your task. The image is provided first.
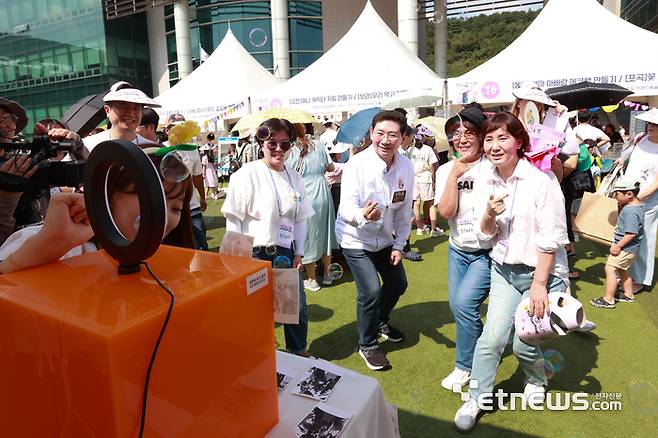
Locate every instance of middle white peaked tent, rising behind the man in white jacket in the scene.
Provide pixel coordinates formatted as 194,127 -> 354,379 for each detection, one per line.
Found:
252,1 -> 443,113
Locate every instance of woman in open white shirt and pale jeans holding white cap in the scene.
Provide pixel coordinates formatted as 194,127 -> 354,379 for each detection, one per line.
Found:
455,112 -> 569,431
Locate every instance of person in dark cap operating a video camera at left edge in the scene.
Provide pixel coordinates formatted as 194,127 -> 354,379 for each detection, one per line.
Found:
0,97 -> 87,244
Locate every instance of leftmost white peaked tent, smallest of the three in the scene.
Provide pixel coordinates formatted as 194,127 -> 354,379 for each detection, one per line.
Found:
155,29 -> 279,121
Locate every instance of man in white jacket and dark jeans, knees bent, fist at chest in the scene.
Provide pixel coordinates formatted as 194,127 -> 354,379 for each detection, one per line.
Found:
336,111 -> 414,370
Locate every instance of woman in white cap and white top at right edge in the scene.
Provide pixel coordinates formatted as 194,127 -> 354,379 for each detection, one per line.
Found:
626,108 -> 658,291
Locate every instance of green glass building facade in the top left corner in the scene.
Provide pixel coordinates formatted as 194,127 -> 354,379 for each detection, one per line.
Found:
0,0 -> 151,131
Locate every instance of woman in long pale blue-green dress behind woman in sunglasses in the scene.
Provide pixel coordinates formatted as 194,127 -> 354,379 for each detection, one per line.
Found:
287,123 -> 338,292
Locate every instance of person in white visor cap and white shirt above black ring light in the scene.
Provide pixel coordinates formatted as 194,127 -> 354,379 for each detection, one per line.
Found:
83,81 -> 160,152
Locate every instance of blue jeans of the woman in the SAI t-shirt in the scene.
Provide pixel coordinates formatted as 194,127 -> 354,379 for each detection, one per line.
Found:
448,246 -> 491,371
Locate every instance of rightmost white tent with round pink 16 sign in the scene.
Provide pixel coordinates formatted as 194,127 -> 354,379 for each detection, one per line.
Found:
449,0 -> 658,103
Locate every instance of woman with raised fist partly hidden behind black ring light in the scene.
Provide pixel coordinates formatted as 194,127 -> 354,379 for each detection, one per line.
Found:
0,148 -> 193,274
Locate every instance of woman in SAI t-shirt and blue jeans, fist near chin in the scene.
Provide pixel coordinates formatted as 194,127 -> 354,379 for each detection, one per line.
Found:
434,108 -> 491,390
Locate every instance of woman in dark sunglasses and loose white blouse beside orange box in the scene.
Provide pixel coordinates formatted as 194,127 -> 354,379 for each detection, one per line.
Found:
222,118 -> 313,355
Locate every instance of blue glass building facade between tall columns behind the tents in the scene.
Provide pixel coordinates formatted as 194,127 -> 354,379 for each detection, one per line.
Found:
165,0 -> 323,85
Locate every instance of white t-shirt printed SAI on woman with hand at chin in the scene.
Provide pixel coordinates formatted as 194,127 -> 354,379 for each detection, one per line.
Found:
434,155 -> 492,252
